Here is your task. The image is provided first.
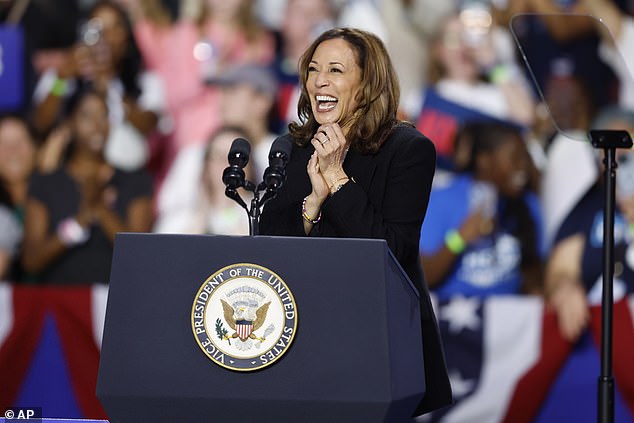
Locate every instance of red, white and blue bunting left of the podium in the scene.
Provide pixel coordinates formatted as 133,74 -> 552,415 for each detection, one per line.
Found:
0,283 -> 108,419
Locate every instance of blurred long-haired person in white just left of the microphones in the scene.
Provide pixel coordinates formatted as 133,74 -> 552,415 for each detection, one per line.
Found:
154,126 -> 253,235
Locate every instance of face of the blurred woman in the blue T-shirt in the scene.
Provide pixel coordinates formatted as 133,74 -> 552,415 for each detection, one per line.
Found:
486,135 -> 529,197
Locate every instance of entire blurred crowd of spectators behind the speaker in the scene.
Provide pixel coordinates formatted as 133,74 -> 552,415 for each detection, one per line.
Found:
0,0 -> 634,338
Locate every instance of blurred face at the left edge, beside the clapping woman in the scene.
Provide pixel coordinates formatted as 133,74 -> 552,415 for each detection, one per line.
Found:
0,119 -> 35,186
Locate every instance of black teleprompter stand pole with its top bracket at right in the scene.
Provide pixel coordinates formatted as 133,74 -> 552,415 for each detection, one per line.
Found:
590,130 -> 632,423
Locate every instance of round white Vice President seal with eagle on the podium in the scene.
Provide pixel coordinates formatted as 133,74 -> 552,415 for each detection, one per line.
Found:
192,263 -> 297,371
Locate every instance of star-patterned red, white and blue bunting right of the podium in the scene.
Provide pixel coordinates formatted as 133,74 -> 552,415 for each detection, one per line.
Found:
417,296 -> 634,423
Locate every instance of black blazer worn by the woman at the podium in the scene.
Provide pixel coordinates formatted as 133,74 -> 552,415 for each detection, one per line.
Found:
259,125 -> 452,414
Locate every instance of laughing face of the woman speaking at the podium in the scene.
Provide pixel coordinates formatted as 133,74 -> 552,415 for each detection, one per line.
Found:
306,38 -> 361,127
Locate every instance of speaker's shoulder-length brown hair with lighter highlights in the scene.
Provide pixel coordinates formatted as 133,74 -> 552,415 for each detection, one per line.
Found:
288,28 -> 400,153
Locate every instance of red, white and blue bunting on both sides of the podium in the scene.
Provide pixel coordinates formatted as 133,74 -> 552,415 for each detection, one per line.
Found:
0,283 -> 634,423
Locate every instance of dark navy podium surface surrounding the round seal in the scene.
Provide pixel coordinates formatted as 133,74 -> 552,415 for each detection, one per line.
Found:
97,233 -> 426,423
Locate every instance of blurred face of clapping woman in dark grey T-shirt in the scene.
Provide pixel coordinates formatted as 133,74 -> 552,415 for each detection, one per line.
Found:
73,94 -> 110,154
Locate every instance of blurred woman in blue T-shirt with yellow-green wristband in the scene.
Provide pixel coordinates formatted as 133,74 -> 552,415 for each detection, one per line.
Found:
420,122 -> 545,300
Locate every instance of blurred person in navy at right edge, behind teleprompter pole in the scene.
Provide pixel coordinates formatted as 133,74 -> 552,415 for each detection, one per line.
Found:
545,106 -> 634,341
